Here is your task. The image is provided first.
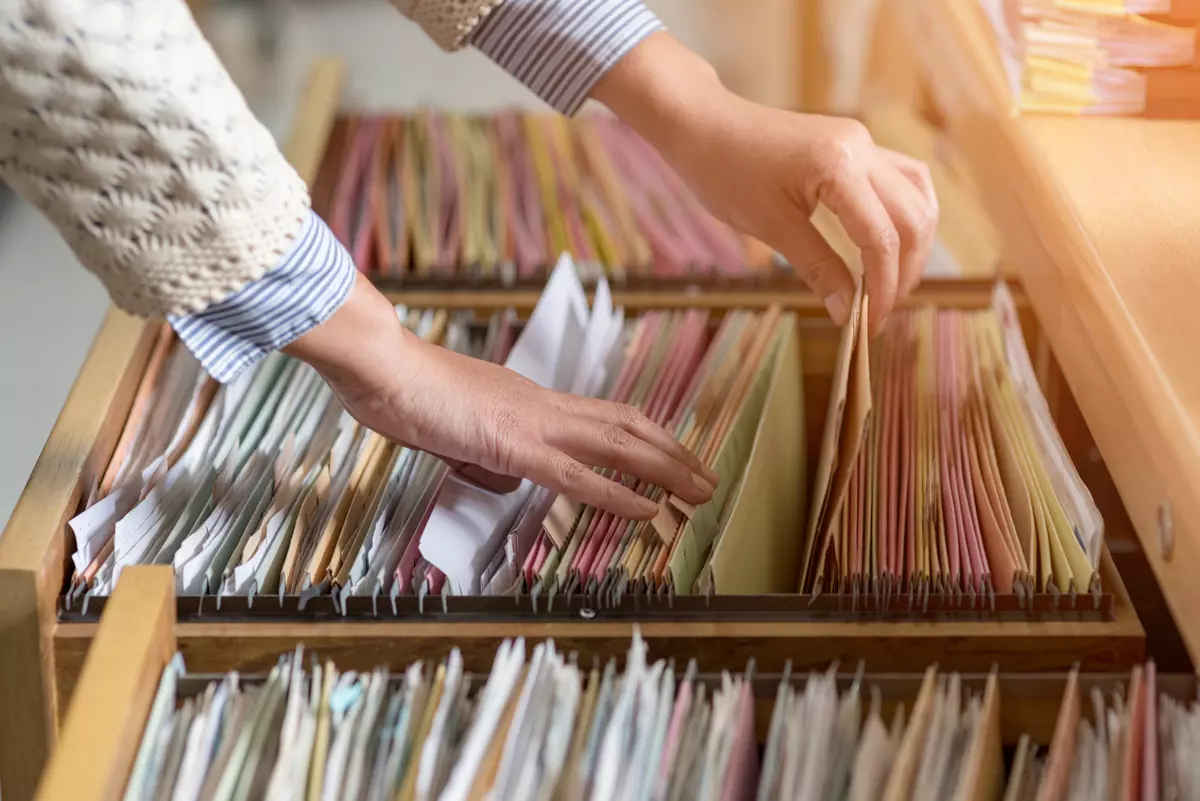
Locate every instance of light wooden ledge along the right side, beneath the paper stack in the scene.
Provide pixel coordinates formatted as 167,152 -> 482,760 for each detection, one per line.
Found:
875,0 -> 1200,662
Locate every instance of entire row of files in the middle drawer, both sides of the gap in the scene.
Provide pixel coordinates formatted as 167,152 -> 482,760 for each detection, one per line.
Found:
66,258 -> 1103,614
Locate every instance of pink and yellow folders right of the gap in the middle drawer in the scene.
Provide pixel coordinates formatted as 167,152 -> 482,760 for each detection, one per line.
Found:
799,284 -> 1103,600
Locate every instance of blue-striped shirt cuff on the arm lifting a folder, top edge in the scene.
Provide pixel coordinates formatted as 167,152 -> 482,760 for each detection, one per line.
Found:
470,0 -> 662,115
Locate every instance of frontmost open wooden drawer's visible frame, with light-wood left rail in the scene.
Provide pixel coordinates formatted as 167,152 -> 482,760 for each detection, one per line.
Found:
37,566 -> 1196,801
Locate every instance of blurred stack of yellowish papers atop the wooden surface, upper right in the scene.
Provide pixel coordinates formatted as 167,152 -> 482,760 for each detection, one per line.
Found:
982,0 -> 1200,116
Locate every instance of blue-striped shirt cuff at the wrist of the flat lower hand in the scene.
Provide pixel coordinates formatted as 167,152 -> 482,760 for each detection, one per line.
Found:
168,211 -> 356,383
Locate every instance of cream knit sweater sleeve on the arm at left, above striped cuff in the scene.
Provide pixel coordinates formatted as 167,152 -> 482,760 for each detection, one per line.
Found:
0,0 -> 308,315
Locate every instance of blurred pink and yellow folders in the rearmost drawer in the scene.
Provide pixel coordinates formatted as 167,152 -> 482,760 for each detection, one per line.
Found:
317,112 -> 780,283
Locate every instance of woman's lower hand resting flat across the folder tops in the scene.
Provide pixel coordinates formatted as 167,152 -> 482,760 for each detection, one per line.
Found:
287,276 -> 716,519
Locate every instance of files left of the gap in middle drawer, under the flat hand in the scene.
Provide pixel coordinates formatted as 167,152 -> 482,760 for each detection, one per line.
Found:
68,257 -> 804,610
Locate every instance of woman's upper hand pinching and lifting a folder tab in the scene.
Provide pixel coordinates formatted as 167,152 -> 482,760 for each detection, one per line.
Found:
592,34 -> 937,331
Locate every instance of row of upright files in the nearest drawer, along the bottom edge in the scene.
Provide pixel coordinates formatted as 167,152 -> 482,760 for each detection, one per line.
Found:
114,631 -> 1200,801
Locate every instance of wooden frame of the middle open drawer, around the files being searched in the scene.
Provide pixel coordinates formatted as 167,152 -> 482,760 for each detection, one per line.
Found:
0,57 -> 1171,799
